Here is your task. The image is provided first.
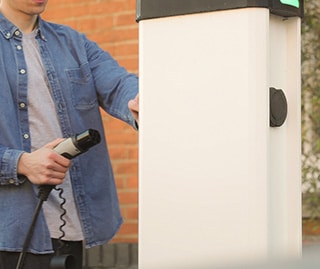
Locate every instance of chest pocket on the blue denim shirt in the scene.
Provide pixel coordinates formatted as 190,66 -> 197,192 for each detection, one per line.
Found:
65,63 -> 98,110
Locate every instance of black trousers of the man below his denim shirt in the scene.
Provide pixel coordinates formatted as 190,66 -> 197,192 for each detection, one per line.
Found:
0,239 -> 83,269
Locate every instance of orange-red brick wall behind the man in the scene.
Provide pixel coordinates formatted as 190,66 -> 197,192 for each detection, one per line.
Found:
42,0 -> 138,242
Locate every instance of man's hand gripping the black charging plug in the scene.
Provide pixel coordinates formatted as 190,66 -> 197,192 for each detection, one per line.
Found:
18,138 -> 71,185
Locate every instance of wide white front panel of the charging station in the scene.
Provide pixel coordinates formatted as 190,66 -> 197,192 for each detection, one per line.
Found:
139,8 -> 302,269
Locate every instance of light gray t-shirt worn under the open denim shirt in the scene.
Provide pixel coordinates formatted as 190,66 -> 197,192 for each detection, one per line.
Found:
22,31 -> 84,240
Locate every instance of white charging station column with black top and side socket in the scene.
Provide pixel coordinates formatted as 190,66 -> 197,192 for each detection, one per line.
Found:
138,0 -> 303,269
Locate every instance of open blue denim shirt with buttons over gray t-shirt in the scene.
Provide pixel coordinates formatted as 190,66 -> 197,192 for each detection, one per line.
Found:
0,14 -> 138,253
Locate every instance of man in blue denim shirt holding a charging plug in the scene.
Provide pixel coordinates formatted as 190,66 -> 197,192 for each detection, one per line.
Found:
0,0 -> 139,269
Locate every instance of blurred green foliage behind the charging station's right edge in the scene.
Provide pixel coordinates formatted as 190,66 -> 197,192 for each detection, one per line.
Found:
302,0 -> 320,218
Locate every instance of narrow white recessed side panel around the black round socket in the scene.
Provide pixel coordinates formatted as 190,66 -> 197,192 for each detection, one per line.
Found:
268,16 -> 302,256
